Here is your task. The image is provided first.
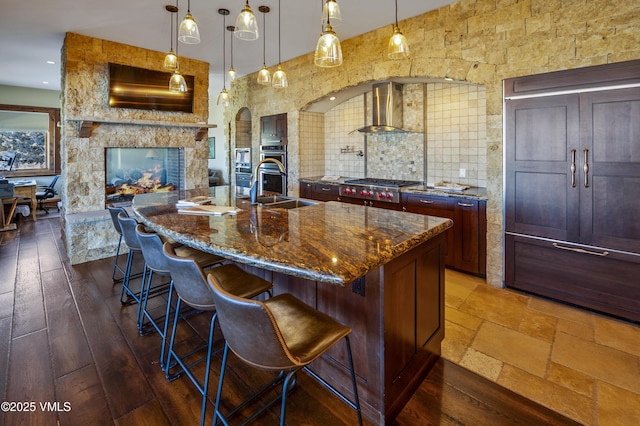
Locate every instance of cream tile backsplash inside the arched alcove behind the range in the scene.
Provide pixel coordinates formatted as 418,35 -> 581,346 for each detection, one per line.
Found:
300,83 -> 487,187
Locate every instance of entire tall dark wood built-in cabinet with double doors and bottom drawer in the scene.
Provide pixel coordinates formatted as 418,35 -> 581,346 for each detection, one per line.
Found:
505,61 -> 640,321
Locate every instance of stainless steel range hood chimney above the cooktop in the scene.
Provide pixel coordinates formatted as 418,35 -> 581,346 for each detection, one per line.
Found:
357,81 -> 407,133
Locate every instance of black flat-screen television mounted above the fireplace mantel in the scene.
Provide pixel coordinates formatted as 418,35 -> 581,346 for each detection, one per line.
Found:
109,63 -> 194,113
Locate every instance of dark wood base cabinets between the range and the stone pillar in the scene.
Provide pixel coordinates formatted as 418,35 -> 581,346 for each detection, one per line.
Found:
402,193 -> 487,276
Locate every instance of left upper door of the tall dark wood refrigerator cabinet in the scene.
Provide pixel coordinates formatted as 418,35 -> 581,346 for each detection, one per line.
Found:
505,95 -> 580,241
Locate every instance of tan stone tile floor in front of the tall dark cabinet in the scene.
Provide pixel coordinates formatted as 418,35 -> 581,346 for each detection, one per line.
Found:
442,270 -> 640,426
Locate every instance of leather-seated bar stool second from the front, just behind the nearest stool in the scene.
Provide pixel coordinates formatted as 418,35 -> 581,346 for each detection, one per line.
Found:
163,243 -> 273,425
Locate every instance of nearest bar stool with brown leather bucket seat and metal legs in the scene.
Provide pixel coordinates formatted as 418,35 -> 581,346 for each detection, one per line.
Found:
207,274 -> 362,425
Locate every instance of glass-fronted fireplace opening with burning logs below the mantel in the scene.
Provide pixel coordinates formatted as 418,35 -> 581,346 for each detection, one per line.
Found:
105,147 -> 184,207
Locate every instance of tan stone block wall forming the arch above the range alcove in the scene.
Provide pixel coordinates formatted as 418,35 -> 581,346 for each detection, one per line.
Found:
225,0 -> 640,287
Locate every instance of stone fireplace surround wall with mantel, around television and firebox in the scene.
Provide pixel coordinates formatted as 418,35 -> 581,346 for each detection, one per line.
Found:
61,33 -> 209,264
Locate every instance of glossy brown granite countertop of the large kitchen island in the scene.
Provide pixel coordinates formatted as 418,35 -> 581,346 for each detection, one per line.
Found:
133,193 -> 453,286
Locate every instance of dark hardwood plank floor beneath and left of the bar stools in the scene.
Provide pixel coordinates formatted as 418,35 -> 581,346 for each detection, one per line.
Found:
0,218 -> 575,425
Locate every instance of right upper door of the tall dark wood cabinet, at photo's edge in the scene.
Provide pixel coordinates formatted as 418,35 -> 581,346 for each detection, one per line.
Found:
579,88 -> 640,253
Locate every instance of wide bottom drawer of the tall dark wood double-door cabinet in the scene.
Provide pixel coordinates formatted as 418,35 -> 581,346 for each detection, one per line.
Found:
505,234 -> 640,321
